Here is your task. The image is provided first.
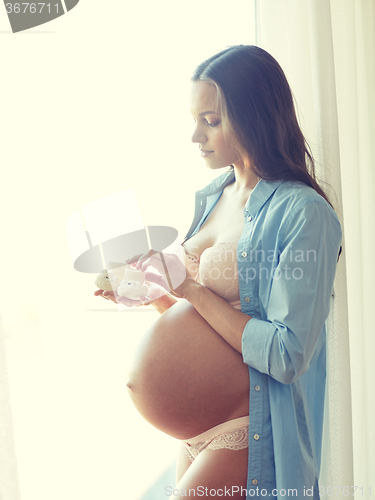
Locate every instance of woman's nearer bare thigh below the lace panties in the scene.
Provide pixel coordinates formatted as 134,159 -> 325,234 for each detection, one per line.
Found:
173,448 -> 249,500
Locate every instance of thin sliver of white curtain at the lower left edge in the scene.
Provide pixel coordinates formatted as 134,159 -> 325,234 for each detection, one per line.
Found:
0,316 -> 21,500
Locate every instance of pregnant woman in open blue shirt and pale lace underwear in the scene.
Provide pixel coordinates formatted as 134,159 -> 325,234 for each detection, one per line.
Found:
95,45 -> 341,499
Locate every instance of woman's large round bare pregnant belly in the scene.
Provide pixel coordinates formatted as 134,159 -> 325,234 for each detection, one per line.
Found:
127,300 -> 249,439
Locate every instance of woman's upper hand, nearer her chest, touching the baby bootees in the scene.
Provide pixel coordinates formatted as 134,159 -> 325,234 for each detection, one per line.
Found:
133,250 -> 196,298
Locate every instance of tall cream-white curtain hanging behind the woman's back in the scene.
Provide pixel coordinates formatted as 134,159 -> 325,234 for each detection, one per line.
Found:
256,0 -> 375,499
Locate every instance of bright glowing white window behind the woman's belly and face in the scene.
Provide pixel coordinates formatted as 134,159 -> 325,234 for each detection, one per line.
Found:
0,0 -> 255,500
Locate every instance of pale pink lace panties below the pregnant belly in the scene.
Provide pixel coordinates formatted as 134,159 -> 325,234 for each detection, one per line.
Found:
181,415 -> 249,462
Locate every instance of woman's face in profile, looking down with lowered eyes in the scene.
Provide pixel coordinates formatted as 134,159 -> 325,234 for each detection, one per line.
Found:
190,81 -> 240,169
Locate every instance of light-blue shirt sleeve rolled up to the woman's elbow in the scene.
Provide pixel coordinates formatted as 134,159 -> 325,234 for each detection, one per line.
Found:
242,201 -> 342,384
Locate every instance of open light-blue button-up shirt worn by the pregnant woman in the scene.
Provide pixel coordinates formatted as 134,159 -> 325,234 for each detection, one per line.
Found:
185,171 -> 342,500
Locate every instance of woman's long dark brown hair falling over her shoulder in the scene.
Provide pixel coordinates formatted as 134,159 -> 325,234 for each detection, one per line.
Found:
192,45 -> 332,206
